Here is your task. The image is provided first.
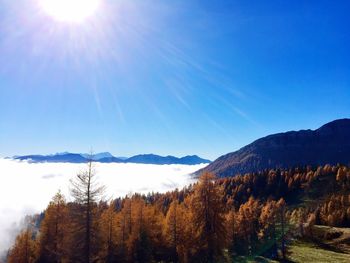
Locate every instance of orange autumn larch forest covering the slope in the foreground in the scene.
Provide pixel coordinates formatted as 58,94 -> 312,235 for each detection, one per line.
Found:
7,162 -> 350,263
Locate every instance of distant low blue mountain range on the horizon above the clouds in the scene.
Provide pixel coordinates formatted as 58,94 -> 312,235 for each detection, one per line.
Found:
12,152 -> 210,165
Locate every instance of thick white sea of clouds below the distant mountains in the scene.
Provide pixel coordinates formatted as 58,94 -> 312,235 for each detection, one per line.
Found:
0,159 -> 206,256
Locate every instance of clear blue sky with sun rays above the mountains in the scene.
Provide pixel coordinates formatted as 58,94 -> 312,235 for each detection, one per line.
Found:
0,0 -> 350,159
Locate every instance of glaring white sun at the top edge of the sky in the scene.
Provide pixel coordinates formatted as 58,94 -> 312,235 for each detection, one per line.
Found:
39,0 -> 101,23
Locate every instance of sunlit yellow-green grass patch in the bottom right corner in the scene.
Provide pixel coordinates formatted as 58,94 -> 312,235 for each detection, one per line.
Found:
289,243 -> 350,263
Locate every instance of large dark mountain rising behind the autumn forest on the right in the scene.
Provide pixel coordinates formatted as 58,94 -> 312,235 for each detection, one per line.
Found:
196,119 -> 350,176
